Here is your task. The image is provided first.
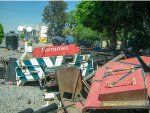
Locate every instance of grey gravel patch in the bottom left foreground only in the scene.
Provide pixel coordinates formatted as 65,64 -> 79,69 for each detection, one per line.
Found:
0,84 -> 46,113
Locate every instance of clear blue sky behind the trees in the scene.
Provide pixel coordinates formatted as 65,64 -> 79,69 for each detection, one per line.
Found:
0,1 -> 78,33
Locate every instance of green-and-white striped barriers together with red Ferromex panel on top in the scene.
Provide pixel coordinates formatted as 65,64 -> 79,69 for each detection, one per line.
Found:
15,44 -> 97,86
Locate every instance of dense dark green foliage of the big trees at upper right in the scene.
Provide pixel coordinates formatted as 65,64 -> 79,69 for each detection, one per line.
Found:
76,1 -> 150,50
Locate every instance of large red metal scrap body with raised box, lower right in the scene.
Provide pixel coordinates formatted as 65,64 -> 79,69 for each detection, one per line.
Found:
82,56 -> 150,112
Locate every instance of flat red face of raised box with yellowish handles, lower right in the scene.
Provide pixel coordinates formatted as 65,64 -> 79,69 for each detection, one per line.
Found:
100,69 -> 145,95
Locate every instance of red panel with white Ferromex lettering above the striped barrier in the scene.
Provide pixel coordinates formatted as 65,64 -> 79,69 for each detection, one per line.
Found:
33,44 -> 80,57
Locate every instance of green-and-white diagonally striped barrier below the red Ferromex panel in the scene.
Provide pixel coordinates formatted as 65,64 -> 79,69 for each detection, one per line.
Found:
15,54 -> 95,85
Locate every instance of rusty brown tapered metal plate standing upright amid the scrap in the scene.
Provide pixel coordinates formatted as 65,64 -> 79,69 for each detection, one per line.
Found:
56,67 -> 82,100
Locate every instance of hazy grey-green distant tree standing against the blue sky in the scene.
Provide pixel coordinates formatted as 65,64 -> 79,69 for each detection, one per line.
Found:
43,1 -> 67,36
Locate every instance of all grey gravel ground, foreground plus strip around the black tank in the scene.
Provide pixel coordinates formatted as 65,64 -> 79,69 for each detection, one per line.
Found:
0,40 -> 55,113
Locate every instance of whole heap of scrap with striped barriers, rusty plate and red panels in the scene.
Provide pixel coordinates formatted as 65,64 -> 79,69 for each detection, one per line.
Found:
1,44 -> 150,113
